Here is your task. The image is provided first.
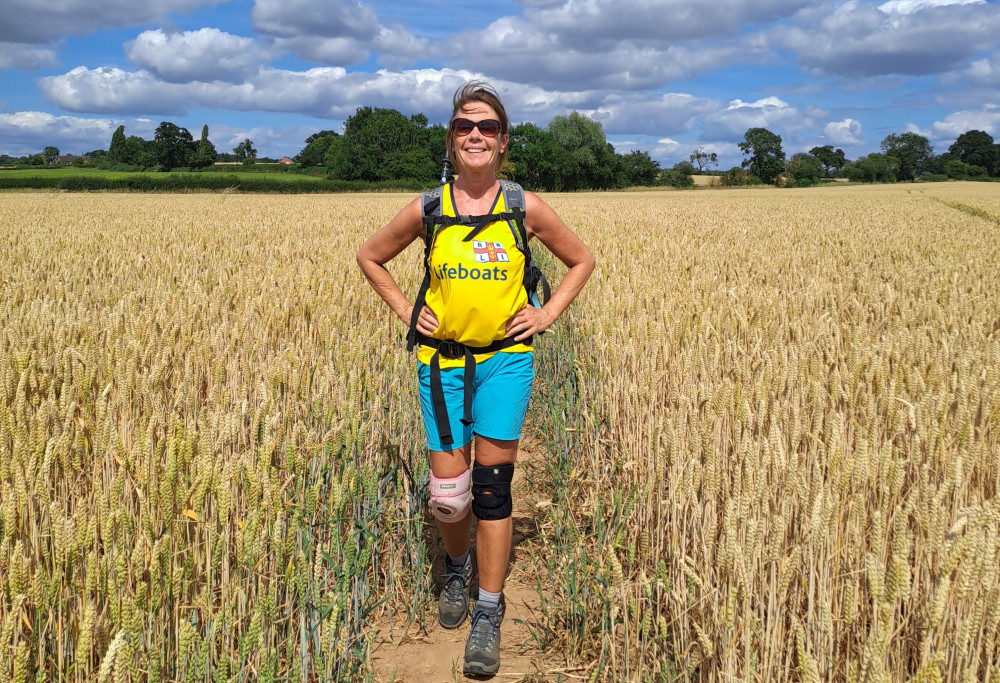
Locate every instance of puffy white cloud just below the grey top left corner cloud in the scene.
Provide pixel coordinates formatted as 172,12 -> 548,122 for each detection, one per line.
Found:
125,28 -> 269,83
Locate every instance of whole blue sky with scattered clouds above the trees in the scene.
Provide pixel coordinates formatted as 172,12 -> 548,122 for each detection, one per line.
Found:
0,0 -> 1000,169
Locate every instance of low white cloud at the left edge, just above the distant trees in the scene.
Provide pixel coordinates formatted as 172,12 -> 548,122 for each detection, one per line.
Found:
0,111 -> 119,156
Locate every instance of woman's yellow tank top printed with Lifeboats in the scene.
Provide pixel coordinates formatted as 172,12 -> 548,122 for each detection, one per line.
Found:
417,183 -> 531,368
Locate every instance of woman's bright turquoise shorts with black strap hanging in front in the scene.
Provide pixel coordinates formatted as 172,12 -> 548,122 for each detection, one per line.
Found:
417,351 -> 535,451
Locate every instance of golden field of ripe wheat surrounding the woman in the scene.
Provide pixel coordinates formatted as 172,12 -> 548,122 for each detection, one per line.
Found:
0,183 -> 1000,683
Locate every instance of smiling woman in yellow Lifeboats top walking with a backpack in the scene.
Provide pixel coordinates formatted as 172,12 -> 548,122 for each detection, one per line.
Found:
358,81 -> 594,675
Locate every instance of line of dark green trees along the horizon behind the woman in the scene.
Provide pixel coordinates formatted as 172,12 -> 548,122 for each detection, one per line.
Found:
0,107 -> 1000,192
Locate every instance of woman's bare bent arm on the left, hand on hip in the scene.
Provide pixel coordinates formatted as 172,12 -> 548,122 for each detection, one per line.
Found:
357,197 -> 438,335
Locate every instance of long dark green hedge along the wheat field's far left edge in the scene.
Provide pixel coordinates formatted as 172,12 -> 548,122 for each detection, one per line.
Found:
0,173 -> 428,194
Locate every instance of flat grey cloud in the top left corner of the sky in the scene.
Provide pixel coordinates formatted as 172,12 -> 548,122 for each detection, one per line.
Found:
0,0 -> 227,43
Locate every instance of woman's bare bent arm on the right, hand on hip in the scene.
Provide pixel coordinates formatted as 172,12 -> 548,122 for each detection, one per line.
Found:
506,192 -> 594,341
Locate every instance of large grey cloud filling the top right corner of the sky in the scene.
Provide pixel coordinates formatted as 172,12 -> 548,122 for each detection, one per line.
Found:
780,0 -> 1000,78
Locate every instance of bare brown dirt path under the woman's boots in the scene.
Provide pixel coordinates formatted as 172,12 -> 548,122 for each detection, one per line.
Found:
371,439 -> 583,683
